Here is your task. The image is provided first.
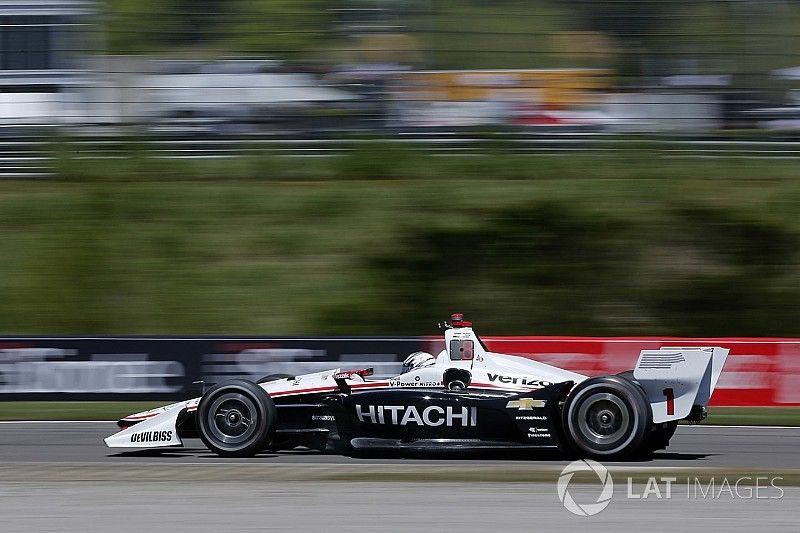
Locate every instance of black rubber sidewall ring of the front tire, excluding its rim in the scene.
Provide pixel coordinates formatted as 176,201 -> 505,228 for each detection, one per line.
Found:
197,380 -> 277,457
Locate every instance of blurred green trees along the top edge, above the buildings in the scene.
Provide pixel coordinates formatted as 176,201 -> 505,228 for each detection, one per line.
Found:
102,0 -> 800,79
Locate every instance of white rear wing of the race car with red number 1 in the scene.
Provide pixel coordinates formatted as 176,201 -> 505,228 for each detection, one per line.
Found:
633,347 -> 729,423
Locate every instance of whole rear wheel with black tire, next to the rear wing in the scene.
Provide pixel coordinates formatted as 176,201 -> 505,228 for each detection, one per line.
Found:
562,376 -> 652,461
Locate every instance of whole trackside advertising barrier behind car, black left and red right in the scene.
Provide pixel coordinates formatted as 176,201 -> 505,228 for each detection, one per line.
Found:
0,337 -> 800,406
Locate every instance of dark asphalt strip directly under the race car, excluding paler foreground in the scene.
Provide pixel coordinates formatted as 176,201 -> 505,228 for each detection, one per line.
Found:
0,422 -> 800,470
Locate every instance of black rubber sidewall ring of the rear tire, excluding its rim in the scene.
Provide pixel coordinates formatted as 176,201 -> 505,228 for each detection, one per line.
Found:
562,376 -> 652,460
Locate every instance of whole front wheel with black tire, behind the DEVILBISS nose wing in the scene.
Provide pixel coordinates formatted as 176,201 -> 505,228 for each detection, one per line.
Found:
197,379 -> 278,457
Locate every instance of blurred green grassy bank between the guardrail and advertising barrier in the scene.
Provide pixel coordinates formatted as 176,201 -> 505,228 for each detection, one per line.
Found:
0,141 -> 800,336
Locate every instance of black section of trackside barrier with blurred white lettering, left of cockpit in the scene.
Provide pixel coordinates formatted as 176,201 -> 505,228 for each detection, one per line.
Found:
0,337 -> 424,400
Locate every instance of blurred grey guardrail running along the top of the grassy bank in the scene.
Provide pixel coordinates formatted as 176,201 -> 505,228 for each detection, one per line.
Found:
0,135 -> 800,178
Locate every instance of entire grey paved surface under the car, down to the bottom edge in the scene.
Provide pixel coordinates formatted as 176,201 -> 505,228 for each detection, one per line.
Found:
0,423 -> 800,533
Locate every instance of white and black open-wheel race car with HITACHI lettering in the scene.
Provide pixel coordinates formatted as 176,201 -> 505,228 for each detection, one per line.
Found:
105,314 -> 728,460
